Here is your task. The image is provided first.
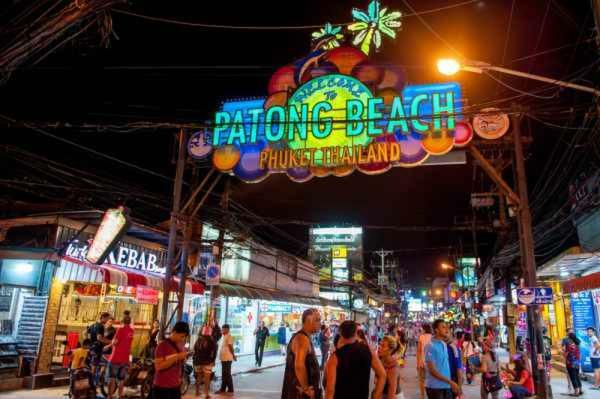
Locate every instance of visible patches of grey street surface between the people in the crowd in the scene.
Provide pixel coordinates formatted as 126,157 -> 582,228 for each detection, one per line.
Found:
0,356 -> 599,399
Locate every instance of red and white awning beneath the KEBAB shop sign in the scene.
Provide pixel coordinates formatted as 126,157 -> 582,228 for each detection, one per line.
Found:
56,256 -> 204,294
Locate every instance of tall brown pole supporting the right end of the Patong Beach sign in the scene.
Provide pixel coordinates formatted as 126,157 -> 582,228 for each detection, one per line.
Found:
512,105 -> 552,399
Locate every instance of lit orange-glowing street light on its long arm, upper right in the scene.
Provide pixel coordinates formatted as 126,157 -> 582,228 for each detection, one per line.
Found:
437,58 -> 600,97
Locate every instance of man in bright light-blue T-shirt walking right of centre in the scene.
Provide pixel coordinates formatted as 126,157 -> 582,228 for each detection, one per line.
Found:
425,319 -> 460,399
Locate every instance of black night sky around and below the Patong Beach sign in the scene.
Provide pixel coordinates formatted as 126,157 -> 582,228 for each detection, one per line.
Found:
0,0 -> 597,281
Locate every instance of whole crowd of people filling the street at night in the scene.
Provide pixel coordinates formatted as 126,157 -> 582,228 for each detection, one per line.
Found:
64,309 -> 600,399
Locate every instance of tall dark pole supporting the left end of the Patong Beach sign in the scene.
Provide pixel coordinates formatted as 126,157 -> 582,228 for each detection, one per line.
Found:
160,129 -> 186,339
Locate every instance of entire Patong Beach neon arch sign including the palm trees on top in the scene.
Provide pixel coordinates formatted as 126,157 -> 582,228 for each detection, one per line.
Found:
198,0 -> 502,183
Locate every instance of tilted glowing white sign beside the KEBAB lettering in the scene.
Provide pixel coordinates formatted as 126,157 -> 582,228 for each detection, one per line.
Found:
85,206 -> 129,265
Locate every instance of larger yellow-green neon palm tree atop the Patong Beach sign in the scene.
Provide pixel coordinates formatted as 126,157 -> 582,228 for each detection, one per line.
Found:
348,0 -> 402,55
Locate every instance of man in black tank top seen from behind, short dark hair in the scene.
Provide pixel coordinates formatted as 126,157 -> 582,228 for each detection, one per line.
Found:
325,320 -> 386,399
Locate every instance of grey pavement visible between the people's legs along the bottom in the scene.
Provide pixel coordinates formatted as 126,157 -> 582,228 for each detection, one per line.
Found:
0,346 -> 600,399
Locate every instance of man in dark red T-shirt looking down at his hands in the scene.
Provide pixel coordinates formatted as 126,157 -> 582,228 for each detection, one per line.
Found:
150,321 -> 190,399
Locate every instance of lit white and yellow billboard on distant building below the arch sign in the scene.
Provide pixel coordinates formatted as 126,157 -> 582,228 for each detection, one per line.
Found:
308,227 -> 363,282
